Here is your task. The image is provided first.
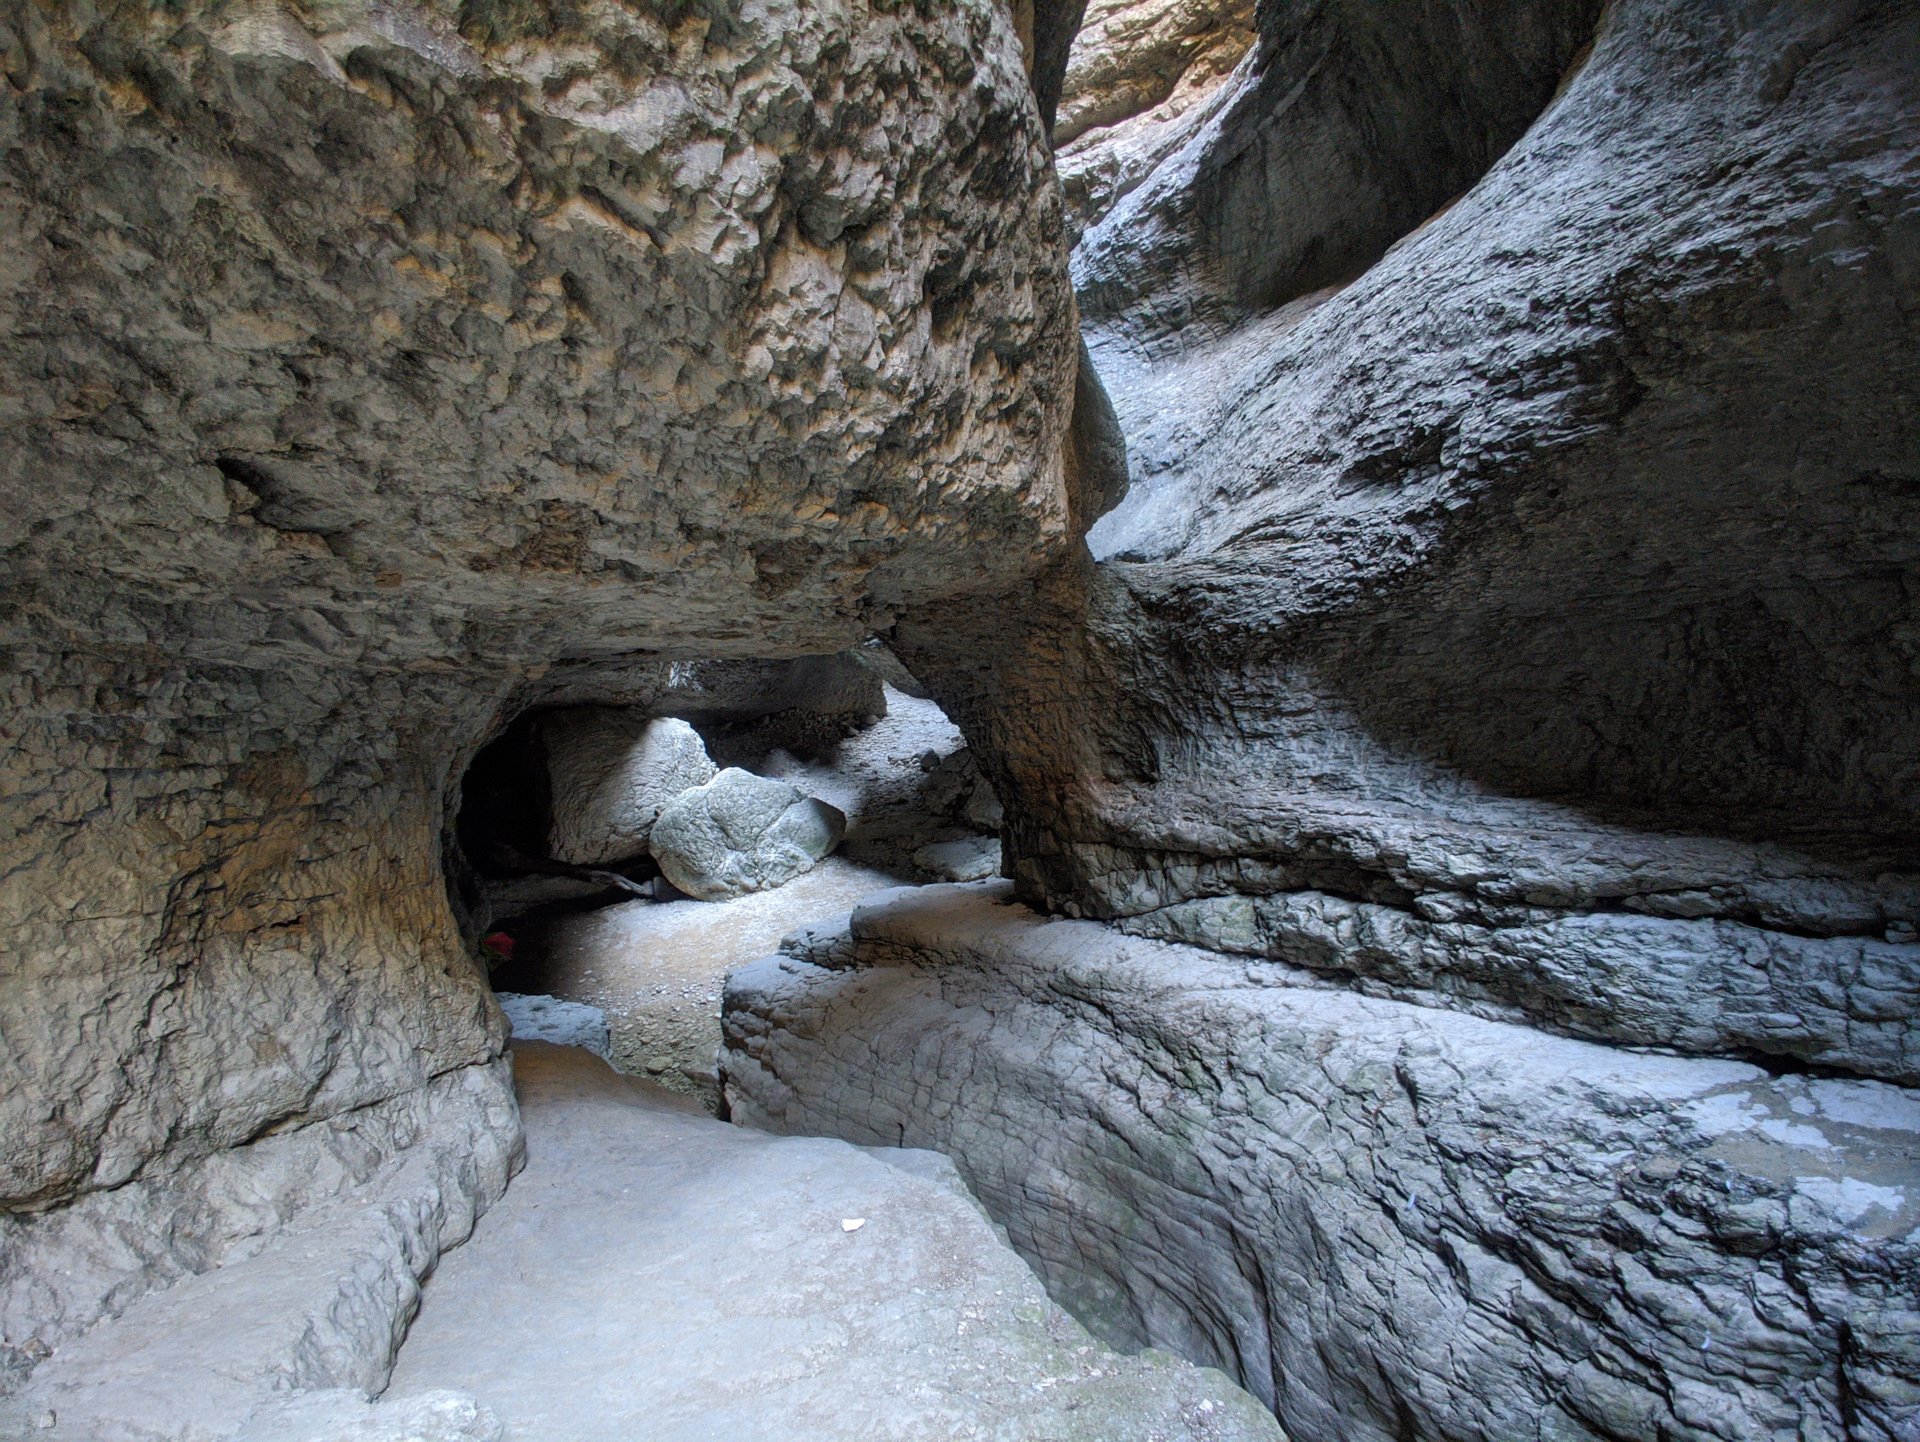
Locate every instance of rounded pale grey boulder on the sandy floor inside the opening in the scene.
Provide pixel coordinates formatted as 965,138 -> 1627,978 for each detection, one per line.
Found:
651,766 -> 847,901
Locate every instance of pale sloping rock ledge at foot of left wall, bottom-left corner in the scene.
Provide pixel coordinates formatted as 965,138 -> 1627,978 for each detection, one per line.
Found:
0,1062 -> 520,1442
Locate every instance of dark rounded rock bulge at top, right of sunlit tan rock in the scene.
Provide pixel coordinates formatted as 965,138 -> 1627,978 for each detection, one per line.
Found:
1073,0 -> 1601,349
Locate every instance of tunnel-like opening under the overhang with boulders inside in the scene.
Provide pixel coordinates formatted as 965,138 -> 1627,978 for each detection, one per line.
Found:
449,649 -> 1000,1114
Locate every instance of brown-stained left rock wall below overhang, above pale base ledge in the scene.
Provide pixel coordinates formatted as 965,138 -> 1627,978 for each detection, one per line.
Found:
0,664 -> 507,1214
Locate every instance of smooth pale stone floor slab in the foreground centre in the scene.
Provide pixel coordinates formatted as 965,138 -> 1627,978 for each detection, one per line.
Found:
392,1043 -> 1283,1442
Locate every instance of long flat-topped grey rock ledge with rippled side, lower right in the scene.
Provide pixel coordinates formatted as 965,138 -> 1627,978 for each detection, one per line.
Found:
724,885 -> 1920,1442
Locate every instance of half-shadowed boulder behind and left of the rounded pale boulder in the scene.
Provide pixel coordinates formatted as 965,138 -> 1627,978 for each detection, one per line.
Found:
540,707 -> 716,866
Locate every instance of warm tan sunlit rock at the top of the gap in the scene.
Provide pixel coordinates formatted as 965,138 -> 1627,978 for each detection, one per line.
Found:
1054,0 -> 1254,242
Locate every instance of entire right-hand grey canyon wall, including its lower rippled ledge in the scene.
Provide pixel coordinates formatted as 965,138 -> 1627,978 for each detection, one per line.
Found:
726,0 -> 1920,1442
